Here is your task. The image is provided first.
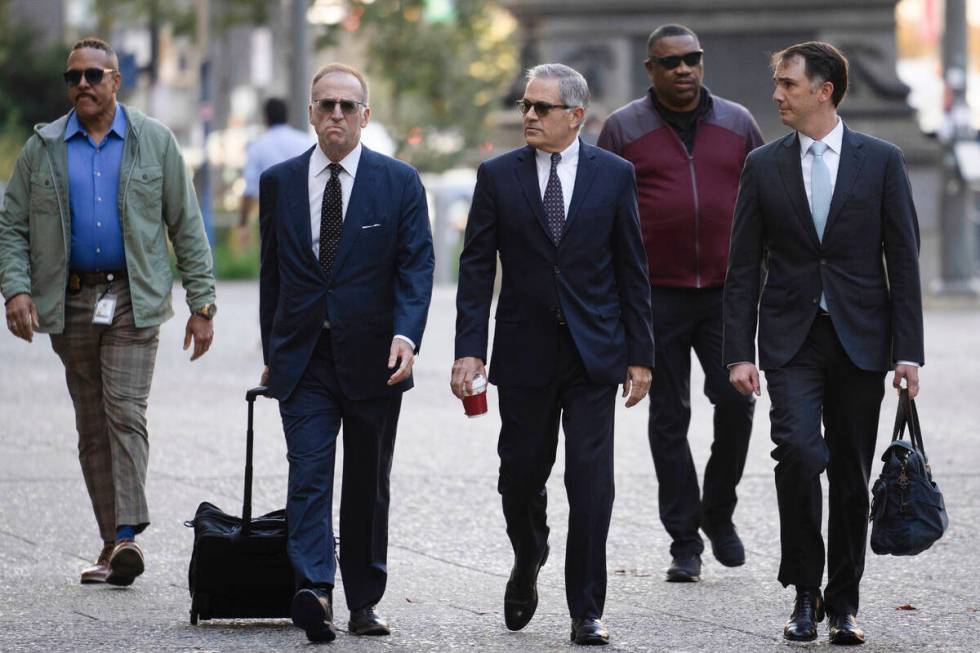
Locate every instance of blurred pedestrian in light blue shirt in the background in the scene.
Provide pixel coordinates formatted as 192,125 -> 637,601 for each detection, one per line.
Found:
238,97 -> 313,248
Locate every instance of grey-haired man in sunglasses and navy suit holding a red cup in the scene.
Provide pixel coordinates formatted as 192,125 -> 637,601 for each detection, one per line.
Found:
452,64 -> 653,644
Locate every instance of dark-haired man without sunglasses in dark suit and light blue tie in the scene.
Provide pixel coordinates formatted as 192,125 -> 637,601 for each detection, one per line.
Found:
724,42 -> 924,644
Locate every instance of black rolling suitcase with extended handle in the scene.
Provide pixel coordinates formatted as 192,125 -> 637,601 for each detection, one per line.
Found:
185,386 -> 295,624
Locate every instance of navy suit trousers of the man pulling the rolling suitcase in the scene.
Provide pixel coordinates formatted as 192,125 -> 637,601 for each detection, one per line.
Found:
279,331 -> 401,610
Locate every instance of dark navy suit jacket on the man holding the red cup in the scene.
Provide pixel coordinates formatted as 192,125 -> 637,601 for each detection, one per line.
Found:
456,143 -> 653,386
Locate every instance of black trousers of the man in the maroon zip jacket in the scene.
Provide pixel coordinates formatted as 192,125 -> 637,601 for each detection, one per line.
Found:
649,287 -> 755,558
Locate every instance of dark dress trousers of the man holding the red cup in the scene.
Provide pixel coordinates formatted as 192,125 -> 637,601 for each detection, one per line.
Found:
497,328 -> 612,618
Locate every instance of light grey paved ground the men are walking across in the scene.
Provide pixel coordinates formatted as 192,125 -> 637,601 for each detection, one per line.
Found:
0,283 -> 980,652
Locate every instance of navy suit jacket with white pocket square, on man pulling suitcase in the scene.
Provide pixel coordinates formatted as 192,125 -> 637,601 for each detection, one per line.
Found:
259,147 -> 434,400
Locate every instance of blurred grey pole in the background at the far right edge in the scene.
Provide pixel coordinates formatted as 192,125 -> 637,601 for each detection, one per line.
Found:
936,0 -> 980,298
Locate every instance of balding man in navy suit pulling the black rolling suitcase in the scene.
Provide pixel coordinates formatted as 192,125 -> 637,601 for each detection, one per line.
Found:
259,64 -> 433,641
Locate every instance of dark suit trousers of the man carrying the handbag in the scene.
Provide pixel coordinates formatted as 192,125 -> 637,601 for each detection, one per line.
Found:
766,315 -> 885,614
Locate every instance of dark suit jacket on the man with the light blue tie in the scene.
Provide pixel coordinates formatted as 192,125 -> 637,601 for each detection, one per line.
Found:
724,126 -> 925,371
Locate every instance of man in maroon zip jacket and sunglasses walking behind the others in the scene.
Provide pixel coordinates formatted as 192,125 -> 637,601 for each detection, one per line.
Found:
598,25 -> 763,582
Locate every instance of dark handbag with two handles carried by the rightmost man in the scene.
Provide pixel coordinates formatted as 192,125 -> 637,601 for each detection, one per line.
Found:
871,388 -> 949,555
